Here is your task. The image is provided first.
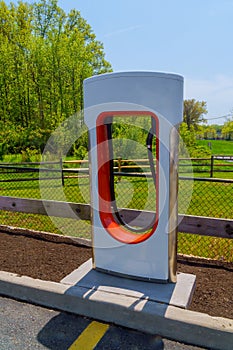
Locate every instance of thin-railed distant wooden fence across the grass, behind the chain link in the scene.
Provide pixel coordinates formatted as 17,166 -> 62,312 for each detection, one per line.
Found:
0,155 -> 233,185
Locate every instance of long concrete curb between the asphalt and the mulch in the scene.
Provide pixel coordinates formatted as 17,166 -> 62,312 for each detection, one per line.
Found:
0,271 -> 233,350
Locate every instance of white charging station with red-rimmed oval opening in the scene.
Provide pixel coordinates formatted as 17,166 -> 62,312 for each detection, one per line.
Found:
84,72 -> 183,283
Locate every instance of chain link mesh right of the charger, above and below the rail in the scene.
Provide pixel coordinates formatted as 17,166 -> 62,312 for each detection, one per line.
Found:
178,177 -> 233,262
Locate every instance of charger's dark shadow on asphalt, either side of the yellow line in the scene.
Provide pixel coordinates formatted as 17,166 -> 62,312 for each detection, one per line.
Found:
37,313 -> 164,350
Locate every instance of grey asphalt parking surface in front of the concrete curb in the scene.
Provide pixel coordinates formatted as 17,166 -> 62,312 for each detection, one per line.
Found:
0,297 -> 206,350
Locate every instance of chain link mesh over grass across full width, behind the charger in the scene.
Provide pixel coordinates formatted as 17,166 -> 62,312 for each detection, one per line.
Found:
0,161 -> 233,261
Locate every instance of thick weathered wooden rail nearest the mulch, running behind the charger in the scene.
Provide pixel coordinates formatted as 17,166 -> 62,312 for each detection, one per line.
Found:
0,196 -> 233,238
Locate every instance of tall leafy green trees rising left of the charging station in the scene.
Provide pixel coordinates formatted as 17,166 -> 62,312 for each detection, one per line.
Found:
0,0 -> 111,151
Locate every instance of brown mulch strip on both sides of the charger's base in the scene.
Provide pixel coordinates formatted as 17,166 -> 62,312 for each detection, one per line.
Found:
0,232 -> 233,319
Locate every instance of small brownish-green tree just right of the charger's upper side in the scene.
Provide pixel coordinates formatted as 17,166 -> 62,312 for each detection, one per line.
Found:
184,99 -> 208,130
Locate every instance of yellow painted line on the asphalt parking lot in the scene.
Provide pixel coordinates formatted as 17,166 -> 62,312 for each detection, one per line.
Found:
68,321 -> 109,350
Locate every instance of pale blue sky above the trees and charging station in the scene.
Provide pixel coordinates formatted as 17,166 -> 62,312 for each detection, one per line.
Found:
7,0 -> 233,123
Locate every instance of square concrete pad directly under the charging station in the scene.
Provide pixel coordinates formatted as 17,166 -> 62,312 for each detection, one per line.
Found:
61,259 -> 196,309
